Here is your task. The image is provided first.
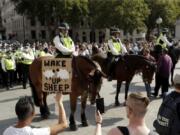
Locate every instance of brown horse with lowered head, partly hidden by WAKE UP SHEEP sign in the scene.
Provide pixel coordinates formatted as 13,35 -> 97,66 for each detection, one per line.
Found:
30,56 -> 103,130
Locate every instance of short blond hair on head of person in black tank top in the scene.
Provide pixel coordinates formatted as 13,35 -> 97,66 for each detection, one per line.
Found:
127,93 -> 150,117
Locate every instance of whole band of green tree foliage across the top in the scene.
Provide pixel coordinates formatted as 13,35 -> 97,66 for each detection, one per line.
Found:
12,0 -> 180,32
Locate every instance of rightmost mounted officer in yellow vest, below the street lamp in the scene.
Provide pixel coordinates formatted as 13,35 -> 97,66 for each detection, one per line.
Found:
156,28 -> 172,49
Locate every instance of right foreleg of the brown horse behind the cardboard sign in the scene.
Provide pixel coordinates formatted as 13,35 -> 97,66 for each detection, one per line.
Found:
81,94 -> 88,127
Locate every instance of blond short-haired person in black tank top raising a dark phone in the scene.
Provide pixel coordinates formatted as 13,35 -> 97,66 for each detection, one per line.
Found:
95,93 -> 156,135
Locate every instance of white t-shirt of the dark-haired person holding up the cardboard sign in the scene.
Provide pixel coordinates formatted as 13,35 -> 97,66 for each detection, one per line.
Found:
3,126 -> 50,135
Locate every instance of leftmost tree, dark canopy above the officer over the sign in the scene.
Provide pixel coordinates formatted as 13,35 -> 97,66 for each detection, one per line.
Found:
12,0 -> 88,25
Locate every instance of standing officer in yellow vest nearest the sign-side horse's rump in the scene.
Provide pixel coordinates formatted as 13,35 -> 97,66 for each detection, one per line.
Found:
22,43 -> 34,89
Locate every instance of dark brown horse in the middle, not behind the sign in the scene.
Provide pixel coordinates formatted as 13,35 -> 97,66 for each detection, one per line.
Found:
92,49 -> 155,106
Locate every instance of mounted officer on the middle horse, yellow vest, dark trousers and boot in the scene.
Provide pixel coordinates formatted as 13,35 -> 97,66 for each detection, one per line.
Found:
108,27 -> 127,81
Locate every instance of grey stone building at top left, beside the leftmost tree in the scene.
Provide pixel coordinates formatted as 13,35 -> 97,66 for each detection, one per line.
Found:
1,0 -> 49,41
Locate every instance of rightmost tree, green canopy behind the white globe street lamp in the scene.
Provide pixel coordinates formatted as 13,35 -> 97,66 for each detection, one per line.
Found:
146,0 -> 180,31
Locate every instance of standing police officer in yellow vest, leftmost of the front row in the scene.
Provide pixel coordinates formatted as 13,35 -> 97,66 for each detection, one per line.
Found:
1,48 -> 16,90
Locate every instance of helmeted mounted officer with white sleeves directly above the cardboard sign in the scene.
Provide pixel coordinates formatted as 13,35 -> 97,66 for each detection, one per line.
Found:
53,23 -> 75,58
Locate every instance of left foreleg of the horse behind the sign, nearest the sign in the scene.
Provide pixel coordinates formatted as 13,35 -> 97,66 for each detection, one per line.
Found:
69,93 -> 77,131
